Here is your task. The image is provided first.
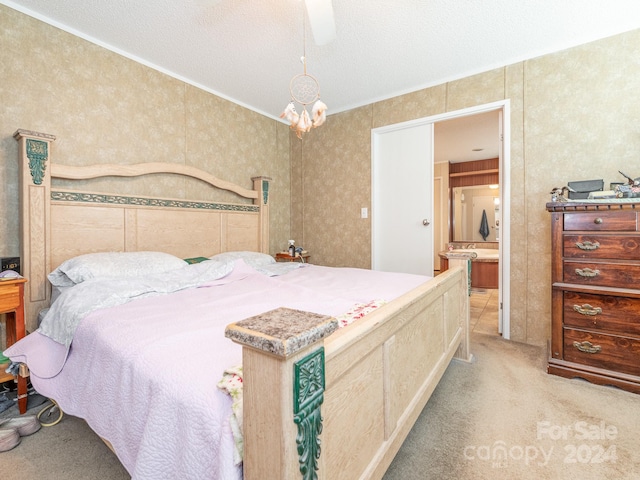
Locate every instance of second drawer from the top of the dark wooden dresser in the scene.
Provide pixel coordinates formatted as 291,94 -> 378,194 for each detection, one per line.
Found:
563,235 -> 640,260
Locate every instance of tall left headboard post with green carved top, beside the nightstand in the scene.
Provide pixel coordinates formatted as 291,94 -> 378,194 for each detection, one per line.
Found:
13,129 -> 56,332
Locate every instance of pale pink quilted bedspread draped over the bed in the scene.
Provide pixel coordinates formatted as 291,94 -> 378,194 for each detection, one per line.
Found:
5,262 -> 428,480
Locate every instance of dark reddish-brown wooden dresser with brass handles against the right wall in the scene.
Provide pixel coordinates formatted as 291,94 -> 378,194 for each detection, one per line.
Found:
547,199 -> 640,393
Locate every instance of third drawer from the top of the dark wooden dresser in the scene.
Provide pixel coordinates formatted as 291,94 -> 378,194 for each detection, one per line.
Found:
562,261 -> 640,289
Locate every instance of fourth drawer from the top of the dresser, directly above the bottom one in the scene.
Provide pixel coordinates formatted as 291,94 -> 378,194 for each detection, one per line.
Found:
563,292 -> 640,338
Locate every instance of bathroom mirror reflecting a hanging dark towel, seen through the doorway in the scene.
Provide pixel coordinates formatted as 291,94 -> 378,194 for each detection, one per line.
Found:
449,185 -> 500,243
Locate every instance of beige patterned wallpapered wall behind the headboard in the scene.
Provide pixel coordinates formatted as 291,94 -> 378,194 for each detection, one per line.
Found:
0,6 -> 290,256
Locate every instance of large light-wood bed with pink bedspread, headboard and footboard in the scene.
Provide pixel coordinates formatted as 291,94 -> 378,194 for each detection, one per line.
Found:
5,130 -> 470,480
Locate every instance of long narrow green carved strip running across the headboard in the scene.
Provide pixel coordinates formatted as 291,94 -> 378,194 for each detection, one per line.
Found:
51,191 -> 259,213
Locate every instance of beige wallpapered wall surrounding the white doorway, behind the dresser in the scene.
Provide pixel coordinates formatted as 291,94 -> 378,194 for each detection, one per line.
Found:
292,30 -> 640,345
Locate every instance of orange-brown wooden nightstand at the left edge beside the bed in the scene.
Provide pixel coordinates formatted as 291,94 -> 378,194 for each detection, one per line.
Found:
0,278 -> 27,414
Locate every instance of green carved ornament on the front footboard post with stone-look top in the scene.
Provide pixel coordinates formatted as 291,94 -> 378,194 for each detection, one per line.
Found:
293,348 -> 324,480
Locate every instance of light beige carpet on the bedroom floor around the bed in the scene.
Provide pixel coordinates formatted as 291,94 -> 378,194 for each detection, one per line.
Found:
0,333 -> 640,480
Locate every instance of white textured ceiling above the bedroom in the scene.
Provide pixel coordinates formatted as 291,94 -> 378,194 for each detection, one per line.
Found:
5,0 -> 640,123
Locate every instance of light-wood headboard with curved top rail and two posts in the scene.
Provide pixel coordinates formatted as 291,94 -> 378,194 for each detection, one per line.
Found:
14,130 -> 271,331
